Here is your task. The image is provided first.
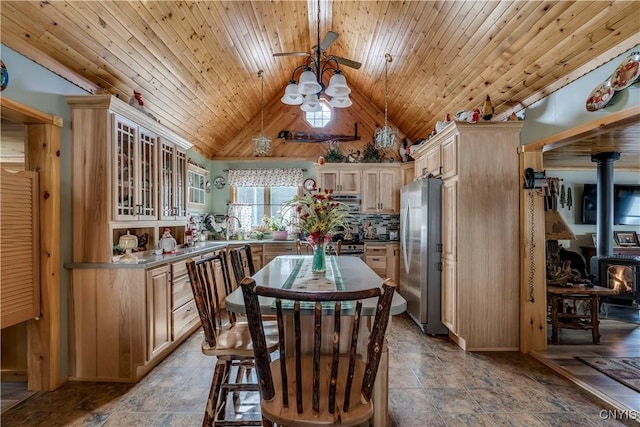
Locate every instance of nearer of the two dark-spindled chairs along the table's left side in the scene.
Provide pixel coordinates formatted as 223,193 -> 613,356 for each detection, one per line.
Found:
186,251 -> 278,426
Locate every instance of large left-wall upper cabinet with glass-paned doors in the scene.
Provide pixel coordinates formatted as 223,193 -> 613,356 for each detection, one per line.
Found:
66,95 -> 191,262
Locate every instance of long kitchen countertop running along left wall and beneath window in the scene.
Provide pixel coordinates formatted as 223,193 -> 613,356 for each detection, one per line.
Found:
64,239 -> 399,269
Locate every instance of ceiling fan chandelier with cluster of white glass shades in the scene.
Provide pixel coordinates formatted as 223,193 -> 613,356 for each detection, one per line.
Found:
274,0 -> 361,112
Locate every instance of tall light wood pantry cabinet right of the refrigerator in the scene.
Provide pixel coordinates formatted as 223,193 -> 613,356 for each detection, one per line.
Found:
413,122 -> 522,351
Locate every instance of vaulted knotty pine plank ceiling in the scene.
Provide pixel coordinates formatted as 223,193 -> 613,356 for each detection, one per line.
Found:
0,0 -> 640,166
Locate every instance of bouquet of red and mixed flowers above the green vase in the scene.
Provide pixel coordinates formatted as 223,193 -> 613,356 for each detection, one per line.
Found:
285,189 -> 349,245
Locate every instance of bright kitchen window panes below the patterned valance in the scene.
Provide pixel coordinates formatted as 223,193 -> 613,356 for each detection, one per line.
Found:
232,187 -> 299,227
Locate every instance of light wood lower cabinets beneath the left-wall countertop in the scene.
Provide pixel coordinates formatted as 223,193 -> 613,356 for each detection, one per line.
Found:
69,261 -> 200,382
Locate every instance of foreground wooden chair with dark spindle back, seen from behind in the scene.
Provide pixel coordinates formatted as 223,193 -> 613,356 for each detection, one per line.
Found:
241,278 -> 396,426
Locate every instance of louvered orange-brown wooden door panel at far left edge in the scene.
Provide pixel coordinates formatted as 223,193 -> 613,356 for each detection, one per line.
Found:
0,169 -> 40,328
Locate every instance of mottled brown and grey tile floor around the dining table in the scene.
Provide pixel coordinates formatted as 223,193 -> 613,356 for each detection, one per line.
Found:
1,315 -> 637,427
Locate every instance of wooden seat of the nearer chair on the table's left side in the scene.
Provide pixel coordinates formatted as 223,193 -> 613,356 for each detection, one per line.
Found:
202,322 -> 278,357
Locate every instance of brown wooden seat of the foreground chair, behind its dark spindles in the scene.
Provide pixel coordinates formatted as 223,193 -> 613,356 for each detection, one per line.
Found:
261,355 -> 373,426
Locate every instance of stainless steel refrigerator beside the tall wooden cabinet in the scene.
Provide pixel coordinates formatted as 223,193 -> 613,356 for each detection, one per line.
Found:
399,178 -> 448,335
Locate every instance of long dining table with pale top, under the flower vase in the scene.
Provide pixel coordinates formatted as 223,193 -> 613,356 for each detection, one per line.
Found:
225,255 -> 407,427
